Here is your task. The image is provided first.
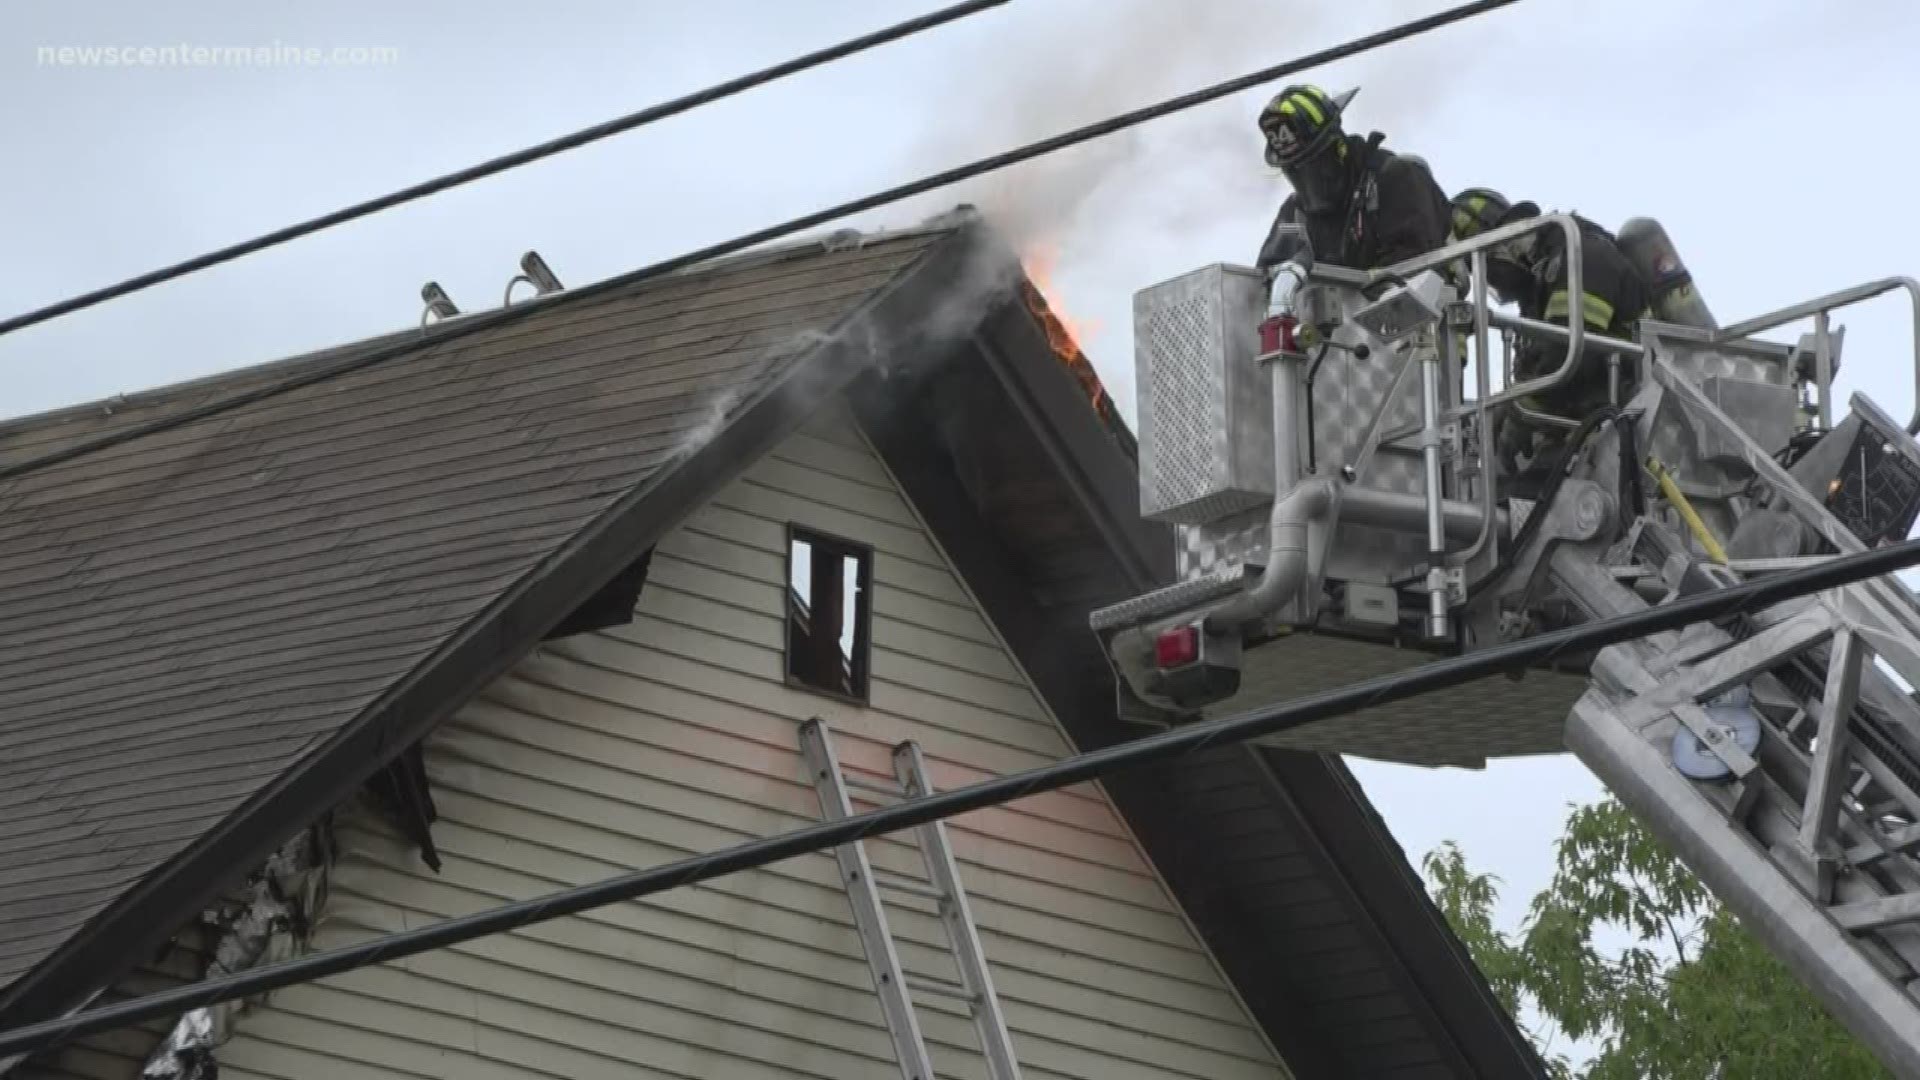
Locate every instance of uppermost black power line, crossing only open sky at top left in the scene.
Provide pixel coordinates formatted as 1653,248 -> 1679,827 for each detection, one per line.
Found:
0,0 -> 1008,334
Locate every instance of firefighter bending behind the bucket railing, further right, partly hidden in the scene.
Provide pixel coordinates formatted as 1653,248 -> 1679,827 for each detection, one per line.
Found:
1452,188 -> 1651,480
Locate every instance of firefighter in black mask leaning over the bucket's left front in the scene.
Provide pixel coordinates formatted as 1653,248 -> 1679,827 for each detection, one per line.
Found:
1256,85 -> 1450,269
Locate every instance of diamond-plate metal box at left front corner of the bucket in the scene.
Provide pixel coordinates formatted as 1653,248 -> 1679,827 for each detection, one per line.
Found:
1133,265 -> 1273,525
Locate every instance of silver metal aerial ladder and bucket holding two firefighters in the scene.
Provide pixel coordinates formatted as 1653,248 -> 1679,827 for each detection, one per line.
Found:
1091,213 -> 1920,1078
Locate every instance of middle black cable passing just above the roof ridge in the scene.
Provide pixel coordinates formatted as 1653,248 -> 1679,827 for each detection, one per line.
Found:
0,0 -> 1519,480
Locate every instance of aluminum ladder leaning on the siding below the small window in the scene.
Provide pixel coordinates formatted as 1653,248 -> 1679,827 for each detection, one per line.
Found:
801,717 -> 1020,1080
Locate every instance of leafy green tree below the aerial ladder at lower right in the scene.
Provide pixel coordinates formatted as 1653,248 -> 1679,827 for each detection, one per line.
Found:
1425,798 -> 1891,1080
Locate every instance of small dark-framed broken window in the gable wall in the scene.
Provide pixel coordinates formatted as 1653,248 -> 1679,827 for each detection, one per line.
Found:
787,527 -> 874,701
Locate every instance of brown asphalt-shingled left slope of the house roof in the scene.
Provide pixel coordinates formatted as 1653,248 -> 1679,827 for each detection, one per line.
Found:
0,224 -> 943,988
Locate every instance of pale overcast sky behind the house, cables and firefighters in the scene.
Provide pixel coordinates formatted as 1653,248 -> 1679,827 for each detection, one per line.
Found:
0,0 -> 1920,1060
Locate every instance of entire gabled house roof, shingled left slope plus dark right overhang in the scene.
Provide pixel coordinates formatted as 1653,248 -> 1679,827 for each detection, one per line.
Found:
0,217 -> 1536,1076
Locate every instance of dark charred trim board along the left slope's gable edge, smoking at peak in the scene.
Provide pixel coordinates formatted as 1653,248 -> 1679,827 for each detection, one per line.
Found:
0,225 -> 1000,1026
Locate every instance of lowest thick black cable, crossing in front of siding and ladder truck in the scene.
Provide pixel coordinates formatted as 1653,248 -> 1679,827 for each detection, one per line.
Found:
0,540 -> 1920,1055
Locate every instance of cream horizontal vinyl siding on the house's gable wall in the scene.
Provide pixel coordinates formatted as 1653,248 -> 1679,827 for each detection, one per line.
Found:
210,399 -> 1286,1080
